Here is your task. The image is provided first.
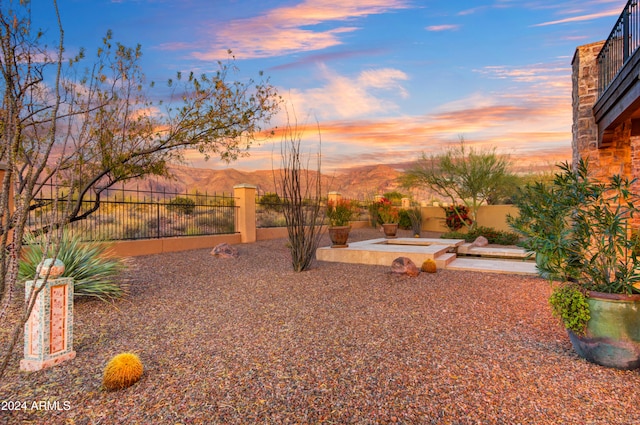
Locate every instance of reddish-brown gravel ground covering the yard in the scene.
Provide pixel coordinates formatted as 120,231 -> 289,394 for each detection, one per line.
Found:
0,229 -> 640,425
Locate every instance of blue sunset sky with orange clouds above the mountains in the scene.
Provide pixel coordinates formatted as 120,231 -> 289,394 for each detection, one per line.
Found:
33,0 -> 626,170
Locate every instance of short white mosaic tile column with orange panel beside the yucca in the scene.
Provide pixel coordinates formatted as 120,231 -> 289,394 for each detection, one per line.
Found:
20,277 -> 76,372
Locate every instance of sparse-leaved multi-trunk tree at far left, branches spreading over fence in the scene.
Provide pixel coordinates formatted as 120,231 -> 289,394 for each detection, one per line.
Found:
0,0 -> 280,377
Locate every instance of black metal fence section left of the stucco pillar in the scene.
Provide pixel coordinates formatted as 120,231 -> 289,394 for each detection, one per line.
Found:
28,183 -> 237,240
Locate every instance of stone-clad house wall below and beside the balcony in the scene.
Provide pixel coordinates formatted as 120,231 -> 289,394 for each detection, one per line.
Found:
572,41 -> 640,186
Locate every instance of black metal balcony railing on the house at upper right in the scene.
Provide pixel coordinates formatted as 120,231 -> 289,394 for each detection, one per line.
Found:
598,0 -> 640,96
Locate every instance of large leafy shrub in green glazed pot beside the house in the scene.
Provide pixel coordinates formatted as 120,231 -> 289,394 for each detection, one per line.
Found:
508,160 -> 640,369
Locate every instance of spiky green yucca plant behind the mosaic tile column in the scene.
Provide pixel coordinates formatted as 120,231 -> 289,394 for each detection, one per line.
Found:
18,232 -> 126,301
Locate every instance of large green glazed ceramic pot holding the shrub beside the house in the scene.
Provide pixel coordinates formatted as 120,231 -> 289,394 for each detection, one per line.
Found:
569,291 -> 640,370
